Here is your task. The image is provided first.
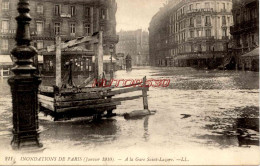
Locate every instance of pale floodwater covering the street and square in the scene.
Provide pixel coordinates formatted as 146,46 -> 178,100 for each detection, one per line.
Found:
0,67 -> 259,164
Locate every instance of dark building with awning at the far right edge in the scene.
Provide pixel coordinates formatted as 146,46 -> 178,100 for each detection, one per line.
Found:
231,0 -> 259,70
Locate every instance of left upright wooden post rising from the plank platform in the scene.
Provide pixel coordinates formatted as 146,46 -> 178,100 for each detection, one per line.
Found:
56,36 -> 62,87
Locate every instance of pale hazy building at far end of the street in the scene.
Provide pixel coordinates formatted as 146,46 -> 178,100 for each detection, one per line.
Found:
116,29 -> 149,65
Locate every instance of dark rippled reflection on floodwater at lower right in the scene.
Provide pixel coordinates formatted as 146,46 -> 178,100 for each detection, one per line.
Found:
197,107 -> 259,148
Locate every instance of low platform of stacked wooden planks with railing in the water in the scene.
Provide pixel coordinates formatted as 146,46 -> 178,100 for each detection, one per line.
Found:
38,77 -> 149,120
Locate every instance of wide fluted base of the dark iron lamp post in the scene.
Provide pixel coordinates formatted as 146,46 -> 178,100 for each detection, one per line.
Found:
8,76 -> 42,150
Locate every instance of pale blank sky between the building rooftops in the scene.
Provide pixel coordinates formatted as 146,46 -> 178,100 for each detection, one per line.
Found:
116,0 -> 167,31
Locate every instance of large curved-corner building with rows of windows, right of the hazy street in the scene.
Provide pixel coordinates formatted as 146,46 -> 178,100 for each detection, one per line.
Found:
149,0 -> 233,67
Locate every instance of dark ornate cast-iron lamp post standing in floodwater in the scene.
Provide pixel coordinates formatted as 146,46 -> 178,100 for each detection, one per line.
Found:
8,0 -> 42,149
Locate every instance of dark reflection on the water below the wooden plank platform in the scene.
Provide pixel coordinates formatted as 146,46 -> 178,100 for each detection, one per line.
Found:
40,119 -> 120,144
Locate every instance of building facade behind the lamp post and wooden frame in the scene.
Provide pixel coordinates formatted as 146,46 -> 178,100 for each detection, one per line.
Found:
0,0 -> 118,74
